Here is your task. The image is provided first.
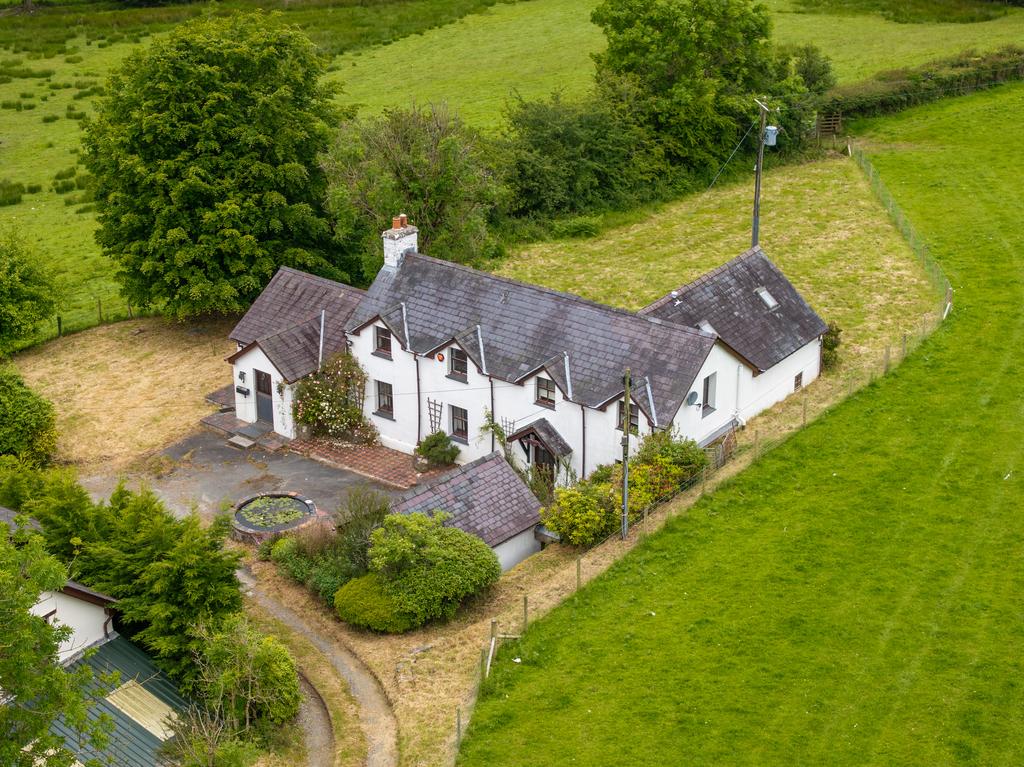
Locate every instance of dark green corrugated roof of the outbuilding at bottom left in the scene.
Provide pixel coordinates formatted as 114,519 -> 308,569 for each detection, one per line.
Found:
50,636 -> 185,767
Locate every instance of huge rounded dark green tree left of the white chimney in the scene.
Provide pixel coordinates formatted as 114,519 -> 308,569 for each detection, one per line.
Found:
85,13 -> 347,316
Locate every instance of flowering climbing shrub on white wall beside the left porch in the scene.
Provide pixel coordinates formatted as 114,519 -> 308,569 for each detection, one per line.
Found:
293,352 -> 377,442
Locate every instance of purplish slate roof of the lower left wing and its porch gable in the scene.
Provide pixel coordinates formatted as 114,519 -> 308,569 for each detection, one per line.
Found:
228,266 -> 366,383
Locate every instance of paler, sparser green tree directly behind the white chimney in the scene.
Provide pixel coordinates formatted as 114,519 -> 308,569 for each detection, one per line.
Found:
324,104 -> 501,280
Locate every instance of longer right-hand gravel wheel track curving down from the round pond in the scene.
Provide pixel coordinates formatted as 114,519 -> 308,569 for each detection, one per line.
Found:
238,568 -> 398,767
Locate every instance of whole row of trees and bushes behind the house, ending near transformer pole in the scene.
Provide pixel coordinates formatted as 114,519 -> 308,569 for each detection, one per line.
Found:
0,0 -> 835,325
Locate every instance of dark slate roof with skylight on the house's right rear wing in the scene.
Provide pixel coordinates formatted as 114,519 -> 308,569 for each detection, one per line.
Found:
640,247 -> 827,372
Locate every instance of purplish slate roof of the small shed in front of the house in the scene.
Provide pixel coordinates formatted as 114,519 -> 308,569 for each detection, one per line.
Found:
391,452 -> 541,547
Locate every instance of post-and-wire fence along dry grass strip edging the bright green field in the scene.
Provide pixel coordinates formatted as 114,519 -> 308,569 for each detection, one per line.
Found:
449,147 -> 953,763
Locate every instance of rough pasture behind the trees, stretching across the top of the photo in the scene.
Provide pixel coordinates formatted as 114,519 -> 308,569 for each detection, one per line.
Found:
0,0 -> 1024,334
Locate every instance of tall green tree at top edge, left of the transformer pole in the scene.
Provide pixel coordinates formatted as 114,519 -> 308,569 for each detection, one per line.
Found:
592,0 -> 776,167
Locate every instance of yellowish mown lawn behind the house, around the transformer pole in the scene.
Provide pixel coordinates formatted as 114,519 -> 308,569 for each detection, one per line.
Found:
499,157 -> 935,357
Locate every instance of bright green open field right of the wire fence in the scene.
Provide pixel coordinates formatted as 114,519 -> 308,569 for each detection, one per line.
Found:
460,80 -> 1024,767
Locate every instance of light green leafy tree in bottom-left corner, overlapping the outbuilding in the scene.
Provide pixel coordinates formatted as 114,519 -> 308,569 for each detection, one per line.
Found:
0,524 -> 108,767
